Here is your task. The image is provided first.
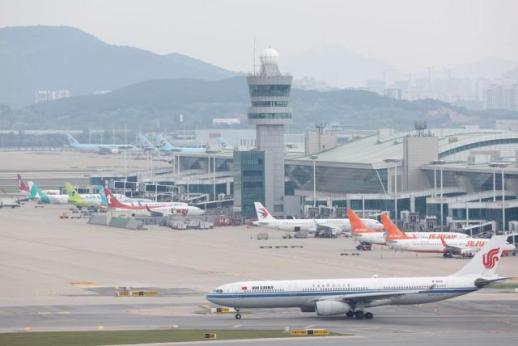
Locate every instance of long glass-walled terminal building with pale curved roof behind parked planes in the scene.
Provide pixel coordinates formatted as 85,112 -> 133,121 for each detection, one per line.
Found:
125,128 -> 518,229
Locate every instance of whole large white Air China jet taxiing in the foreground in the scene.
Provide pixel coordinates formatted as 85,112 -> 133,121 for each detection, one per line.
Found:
207,236 -> 507,319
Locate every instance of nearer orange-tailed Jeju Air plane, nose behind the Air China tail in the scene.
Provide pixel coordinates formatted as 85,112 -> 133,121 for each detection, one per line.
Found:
381,214 -> 516,256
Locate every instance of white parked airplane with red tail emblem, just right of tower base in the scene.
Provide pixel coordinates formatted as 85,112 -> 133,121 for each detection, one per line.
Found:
253,202 -> 383,235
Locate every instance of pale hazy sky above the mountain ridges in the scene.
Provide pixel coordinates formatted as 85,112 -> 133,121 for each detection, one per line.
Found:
0,0 -> 518,71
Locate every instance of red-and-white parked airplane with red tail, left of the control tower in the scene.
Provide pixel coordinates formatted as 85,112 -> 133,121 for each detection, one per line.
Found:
104,188 -> 205,216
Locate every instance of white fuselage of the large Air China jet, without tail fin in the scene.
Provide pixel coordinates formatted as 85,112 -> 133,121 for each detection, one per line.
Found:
207,276 -> 478,312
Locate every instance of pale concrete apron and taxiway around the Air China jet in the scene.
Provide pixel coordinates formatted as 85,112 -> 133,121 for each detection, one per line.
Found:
0,203 -> 518,345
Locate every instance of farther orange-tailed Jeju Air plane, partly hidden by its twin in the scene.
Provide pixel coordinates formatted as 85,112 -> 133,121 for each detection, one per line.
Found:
347,209 -> 468,245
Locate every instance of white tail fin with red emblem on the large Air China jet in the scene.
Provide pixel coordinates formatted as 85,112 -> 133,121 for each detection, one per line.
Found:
458,235 -> 507,277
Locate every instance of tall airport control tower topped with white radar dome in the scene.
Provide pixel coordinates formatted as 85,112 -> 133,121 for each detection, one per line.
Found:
247,48 -> 293,216
